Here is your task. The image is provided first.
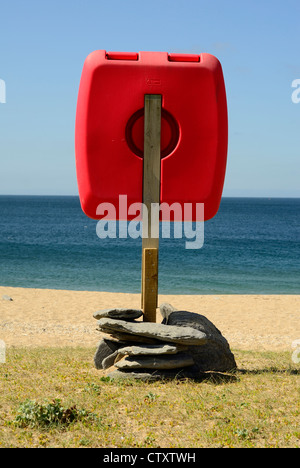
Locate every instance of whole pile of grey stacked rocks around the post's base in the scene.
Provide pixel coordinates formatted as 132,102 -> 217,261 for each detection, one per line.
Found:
94,304 -> 236,380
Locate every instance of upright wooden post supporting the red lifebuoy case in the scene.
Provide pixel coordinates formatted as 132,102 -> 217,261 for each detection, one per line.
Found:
141,94 -> 162,322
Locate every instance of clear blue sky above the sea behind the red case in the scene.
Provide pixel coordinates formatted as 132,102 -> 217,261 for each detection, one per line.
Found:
0,0 -> 300,197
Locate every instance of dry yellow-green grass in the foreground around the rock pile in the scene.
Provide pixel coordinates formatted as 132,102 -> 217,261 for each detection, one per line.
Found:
0,348 -> 300,448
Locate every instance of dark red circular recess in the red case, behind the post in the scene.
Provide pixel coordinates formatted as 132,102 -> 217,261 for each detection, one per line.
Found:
125,109 -> 179,159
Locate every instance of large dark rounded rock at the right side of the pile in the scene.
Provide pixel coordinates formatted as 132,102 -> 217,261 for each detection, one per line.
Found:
159,304 -> 236,372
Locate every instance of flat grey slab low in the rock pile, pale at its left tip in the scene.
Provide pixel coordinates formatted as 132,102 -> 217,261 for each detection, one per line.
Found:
115,353 -> 194,370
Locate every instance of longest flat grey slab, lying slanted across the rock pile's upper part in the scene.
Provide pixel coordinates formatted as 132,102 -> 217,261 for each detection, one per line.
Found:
98,318 -> 207,346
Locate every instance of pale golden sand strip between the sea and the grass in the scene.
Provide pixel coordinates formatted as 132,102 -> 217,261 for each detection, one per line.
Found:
0,287 -> 300,351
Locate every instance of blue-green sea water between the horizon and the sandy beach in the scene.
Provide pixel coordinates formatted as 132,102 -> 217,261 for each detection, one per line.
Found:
0,196 -> 300,294
